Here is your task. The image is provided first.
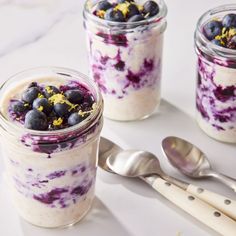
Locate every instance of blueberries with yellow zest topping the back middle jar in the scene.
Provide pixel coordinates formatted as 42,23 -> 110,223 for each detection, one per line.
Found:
94,0 -> 160,22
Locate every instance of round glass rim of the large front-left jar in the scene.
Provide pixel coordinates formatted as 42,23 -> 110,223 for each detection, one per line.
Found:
0,66 -> 103,136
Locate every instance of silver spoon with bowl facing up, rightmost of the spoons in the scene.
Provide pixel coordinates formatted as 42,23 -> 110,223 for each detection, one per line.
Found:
162,137 -> 236,192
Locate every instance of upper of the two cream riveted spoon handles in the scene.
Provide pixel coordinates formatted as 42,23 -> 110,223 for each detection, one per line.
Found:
187,184 -> 236,220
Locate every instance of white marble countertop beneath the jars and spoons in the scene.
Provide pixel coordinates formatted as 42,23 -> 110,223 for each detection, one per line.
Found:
0,0 -> 236,236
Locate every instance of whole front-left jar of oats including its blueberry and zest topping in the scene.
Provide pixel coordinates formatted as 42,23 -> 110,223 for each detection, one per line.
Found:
0,67 -> 103,227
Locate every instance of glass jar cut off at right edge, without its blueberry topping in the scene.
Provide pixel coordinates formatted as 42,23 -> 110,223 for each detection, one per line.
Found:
195,4 -> 236,143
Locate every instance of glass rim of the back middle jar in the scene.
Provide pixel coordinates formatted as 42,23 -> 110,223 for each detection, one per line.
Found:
83,0 -> 168,30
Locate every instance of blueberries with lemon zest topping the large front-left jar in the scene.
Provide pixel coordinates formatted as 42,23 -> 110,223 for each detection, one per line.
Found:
9,82 -> 94,130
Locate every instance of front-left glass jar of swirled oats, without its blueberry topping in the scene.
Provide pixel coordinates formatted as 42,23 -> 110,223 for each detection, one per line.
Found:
0,67 -> 103,227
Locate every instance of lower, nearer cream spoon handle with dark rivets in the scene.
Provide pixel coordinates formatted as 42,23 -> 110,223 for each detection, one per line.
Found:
150,178 -> 236,236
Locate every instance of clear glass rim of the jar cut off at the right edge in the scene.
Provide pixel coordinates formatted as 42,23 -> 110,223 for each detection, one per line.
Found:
195,4 -> 236,59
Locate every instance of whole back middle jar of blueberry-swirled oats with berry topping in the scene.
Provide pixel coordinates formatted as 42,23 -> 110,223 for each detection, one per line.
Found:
84,0 -> 167,121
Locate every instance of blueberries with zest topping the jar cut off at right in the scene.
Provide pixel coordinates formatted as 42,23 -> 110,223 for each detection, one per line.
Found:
203,13 -> 236,49
